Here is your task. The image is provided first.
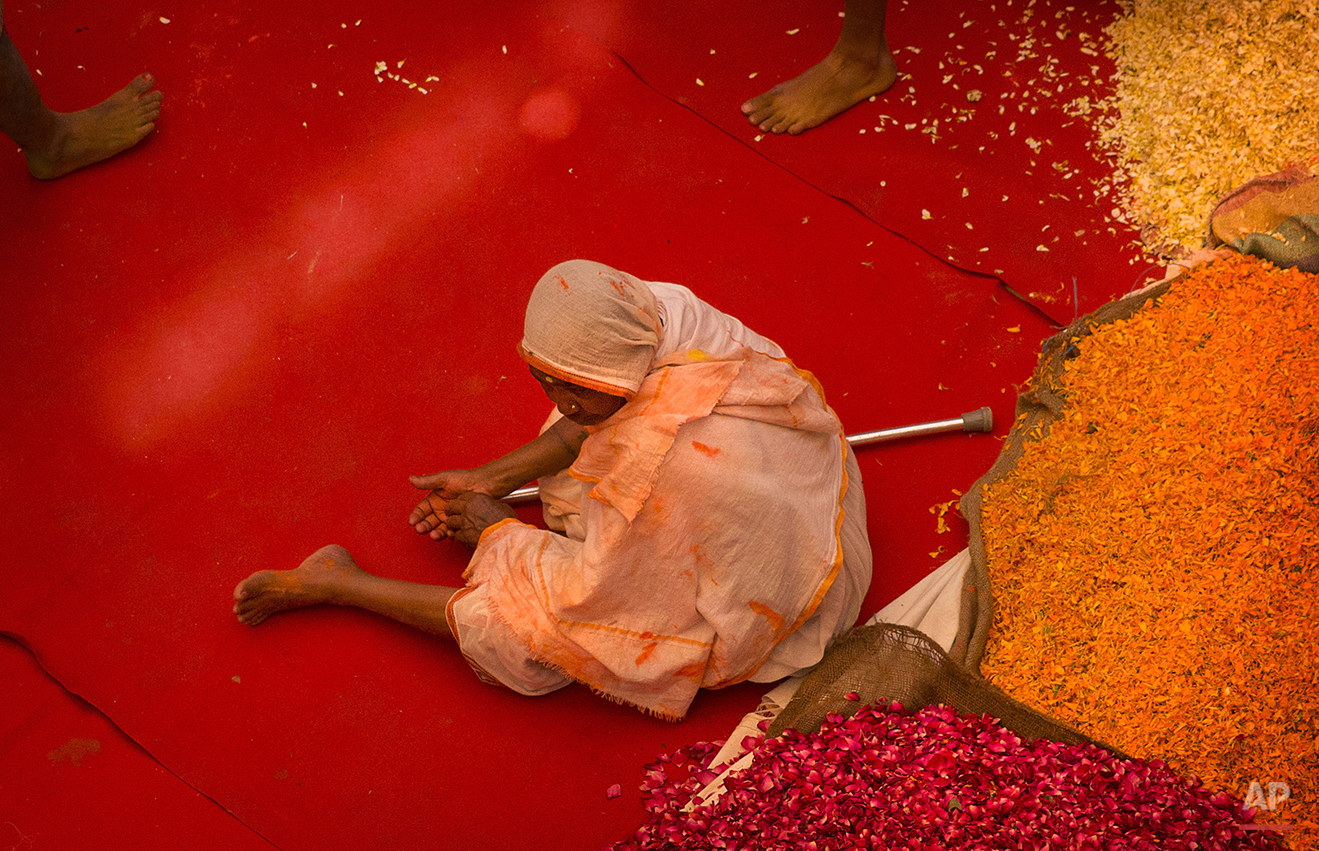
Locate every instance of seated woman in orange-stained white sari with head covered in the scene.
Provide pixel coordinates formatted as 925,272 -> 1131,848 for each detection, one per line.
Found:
235,260 -> 871,719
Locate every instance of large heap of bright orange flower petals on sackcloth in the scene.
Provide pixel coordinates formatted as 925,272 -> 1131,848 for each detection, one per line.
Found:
981,256 -> 1319,848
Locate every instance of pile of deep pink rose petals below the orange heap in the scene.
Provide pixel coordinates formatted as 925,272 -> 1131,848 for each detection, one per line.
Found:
612,695 -> 1275,851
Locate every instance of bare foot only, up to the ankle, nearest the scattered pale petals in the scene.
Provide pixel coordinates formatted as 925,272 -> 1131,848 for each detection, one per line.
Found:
743,49 -> 898,136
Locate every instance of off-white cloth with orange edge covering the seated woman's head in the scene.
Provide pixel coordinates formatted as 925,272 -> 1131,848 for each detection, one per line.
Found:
517,260 -> 660,398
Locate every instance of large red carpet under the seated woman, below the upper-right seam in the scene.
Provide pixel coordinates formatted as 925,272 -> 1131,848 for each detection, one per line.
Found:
0,0 -> 1125,850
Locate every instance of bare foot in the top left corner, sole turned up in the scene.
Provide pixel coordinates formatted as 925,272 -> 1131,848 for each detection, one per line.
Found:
22,74 -> 162,181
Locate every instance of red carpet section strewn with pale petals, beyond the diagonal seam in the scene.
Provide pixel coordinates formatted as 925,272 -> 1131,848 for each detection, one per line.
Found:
575,0 -> 1149,323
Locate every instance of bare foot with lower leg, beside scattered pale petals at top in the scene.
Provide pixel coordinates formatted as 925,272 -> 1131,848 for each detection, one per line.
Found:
741,0 -> 897,136
